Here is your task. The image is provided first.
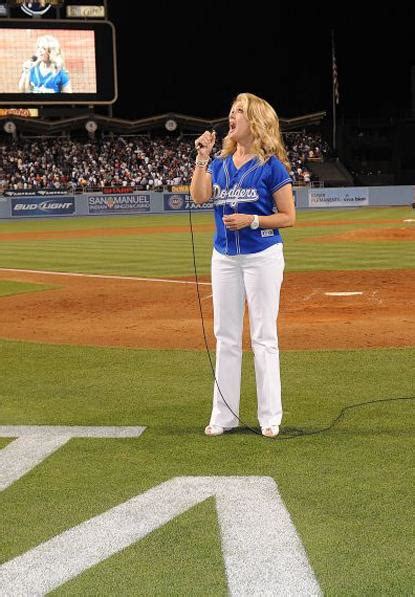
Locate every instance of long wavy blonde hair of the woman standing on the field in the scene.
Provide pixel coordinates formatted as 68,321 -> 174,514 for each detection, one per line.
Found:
220,93 -> 291,170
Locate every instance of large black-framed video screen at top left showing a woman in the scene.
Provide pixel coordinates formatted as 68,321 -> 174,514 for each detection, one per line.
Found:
0,19 -> 117,104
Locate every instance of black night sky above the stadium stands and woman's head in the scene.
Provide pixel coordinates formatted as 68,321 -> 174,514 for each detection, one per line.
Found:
108,0 -> 415,119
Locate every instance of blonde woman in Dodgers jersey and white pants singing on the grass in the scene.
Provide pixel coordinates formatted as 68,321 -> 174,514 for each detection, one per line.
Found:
190,93 -> 295,437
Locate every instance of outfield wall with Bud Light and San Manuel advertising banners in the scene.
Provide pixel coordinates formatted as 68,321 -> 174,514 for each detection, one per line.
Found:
0,186 -> 415,219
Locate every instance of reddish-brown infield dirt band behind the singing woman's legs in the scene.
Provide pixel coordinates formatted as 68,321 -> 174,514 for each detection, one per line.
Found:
0,270 -> 415,350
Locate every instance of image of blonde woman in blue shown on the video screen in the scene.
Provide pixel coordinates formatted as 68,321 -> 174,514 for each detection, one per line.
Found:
19,35 -> 72,93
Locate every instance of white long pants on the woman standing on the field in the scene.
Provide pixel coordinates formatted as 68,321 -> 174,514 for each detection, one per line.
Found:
210,244 -> 284,427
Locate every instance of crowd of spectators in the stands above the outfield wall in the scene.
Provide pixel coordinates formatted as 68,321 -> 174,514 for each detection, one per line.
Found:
0,132 -> 330,191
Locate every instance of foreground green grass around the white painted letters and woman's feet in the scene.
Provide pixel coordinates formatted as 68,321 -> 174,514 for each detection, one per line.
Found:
0,342 -> 415,596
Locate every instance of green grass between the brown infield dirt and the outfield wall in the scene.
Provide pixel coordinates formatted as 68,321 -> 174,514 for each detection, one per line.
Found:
0,207 -> 415,278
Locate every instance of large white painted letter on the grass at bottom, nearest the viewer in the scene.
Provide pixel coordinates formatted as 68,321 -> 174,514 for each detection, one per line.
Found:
0,477 -> 321,597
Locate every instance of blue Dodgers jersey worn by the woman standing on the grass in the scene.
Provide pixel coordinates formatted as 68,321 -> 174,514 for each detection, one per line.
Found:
208,156 -> 292,255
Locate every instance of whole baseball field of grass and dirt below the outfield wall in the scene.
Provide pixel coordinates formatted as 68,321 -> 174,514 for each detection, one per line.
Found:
0,206 -> 415,597
